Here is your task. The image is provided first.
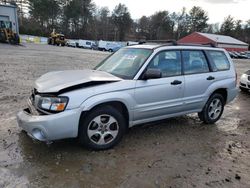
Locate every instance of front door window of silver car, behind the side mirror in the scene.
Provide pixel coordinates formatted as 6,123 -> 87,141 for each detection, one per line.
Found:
148,51 -> 181,77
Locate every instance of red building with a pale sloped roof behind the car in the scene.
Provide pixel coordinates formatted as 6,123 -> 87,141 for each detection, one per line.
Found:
178,32 -> 248,52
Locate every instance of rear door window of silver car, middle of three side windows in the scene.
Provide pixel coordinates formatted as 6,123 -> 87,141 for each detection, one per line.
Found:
182,50 -> 209,74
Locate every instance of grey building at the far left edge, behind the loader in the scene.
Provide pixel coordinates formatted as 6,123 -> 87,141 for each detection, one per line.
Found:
0,4 -> 19,35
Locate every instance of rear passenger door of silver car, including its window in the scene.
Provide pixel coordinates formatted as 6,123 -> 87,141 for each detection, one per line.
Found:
182,50 -> 215,111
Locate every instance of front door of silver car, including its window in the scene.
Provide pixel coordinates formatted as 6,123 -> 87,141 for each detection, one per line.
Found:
134,50 -> 184,121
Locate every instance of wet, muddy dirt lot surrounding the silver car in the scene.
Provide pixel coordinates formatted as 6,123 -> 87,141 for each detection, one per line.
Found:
0,44 -> 250,188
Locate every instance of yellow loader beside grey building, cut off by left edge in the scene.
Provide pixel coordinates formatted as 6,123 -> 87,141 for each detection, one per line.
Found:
0,20 -> 20,44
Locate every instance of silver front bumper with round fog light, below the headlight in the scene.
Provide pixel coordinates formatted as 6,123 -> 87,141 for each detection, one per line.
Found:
17,108 -> 81,141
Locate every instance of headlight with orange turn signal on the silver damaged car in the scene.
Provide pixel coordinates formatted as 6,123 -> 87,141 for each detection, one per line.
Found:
38,97 -> 69,112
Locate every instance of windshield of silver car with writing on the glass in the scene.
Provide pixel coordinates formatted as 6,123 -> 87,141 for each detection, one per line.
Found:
95,48 -> 152,79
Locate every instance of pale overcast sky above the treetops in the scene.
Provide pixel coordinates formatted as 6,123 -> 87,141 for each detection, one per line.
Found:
93,0 -> 250,23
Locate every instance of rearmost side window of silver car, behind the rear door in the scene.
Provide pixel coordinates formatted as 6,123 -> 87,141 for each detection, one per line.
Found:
208,51 -> 230,71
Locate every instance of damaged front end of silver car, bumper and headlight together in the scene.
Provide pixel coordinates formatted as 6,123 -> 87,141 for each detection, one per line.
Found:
17,89 -> 81,143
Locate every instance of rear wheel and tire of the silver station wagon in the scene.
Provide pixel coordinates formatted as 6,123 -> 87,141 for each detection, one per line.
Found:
198,93 -> 225,124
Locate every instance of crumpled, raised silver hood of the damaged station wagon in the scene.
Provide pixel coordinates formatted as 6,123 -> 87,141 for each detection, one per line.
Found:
35,69 -> 122,93
